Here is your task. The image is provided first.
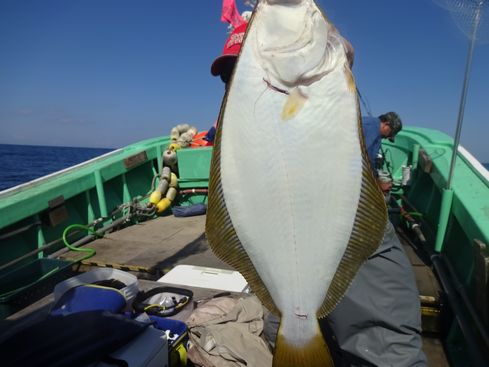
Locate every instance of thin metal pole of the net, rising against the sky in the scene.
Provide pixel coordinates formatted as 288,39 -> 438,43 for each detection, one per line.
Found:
447,1 -> 484,190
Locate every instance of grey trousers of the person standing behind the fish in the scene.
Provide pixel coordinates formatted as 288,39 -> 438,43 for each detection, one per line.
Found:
265,222 -> 427,367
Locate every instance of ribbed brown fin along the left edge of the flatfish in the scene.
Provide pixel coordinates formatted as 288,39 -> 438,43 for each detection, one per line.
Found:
205,107 -> 280,315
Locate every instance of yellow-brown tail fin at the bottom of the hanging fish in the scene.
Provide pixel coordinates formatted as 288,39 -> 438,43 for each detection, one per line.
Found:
273,321 -> 334,367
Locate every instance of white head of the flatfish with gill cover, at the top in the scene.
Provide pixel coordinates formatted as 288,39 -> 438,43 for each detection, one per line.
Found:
250,0 -> 352,89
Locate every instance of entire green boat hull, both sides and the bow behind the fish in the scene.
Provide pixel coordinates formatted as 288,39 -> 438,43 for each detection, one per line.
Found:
0,127 -> 489,366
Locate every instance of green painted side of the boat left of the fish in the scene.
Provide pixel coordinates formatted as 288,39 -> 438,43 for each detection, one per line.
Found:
0,137 -> 169,265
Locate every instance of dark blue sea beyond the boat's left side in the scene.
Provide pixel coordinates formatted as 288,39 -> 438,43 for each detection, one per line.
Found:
0,144 -> 113,191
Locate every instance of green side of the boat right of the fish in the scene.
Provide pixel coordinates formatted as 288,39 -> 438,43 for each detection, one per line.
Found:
383,128 -> 489,366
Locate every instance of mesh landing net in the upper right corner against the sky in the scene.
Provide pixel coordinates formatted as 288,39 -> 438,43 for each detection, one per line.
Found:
433,0 -> 489,44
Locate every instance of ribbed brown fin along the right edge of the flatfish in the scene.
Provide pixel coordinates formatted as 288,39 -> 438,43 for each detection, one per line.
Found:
318,115 -> 387,317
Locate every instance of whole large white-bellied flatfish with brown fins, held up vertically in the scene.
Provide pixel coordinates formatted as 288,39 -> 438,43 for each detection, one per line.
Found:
206,0 -> 387,367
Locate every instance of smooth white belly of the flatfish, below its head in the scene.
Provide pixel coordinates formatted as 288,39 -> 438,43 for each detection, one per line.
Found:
221,1 -> 362,344
